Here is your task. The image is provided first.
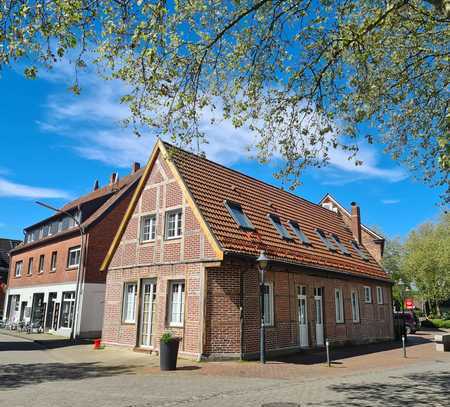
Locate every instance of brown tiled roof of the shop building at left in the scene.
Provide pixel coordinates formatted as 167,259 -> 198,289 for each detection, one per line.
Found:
13,169 -> 144,252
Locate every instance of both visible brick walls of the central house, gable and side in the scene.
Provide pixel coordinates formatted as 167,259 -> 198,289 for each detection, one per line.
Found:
103,147 -> 393,358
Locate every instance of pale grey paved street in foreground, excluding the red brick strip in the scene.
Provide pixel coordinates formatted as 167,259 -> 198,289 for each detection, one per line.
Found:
0,335 -> 450,407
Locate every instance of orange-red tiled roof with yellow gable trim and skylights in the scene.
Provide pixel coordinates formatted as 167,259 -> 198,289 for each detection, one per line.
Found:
101,141 -> 388,279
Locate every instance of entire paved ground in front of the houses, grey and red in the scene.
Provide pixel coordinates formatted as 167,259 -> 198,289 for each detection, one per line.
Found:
0,332 -> 450,407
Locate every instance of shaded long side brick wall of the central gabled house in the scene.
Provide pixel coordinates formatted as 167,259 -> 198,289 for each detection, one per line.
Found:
205,259 -> 393,355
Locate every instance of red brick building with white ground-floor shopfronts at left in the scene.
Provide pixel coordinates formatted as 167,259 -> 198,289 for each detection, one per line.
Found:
4,163 -> 142,337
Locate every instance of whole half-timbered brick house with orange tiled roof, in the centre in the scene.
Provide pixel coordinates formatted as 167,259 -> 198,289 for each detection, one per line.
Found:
102,141 -> 393,358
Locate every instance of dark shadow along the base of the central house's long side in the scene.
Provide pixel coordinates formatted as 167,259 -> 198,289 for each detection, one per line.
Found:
269,335 -> 432,365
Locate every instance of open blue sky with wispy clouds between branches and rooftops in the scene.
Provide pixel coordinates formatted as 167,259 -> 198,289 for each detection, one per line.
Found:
0,65 -> 440,239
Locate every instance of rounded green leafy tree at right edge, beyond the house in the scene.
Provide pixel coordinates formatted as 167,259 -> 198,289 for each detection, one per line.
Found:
401,213 -> 450,315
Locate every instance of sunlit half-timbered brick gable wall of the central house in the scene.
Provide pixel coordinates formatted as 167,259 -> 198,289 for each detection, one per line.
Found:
103,151 -> 220,355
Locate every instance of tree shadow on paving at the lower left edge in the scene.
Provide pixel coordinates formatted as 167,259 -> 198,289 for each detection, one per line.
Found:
0,362 -> 133,391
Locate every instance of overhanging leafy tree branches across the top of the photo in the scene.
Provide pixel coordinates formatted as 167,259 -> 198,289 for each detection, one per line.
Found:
0,0 -> 450,201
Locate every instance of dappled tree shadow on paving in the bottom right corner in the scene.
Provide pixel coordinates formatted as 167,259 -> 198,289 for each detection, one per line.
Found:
320,372 -> 450,407
